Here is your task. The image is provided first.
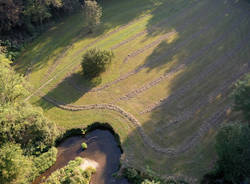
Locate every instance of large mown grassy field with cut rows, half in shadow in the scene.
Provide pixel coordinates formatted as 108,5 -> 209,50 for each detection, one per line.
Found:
16,0 -> 250,180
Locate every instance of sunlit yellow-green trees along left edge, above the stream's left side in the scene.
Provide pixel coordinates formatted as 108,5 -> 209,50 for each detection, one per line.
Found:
0,55 -> 58,154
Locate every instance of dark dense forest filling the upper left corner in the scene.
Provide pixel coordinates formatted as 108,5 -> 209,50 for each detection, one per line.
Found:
0,0 -> 83,61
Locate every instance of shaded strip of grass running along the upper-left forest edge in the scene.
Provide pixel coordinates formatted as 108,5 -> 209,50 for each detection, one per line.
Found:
16,0 -> 164,74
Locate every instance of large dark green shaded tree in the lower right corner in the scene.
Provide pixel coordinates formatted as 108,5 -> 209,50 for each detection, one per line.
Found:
216,124 -> 250,183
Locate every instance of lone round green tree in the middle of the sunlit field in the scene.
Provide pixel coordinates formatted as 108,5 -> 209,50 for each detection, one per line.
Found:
82,48 -> 114,79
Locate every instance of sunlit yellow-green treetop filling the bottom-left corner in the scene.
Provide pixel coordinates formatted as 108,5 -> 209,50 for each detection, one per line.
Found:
0,143 -> 32,184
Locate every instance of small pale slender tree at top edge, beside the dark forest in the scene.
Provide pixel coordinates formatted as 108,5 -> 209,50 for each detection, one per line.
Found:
84,0 -> 102,32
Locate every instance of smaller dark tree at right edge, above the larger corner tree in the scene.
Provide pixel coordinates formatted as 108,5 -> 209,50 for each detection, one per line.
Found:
233,74 -> 250,121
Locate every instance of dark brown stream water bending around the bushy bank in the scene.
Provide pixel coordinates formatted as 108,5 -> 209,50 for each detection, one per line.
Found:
33,129 -> 128,184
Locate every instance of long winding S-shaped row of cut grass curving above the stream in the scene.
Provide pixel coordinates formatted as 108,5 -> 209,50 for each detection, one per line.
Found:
32,33 -> 250,156
